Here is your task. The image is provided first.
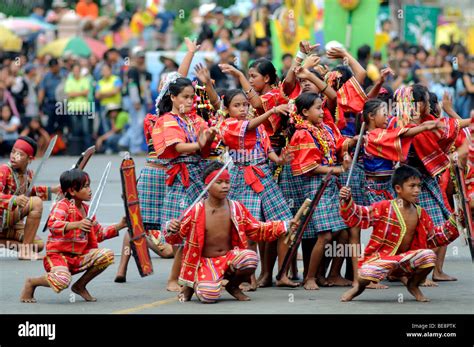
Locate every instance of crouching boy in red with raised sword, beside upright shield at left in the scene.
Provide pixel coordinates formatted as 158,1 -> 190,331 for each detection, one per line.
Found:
20,169 -> 127,303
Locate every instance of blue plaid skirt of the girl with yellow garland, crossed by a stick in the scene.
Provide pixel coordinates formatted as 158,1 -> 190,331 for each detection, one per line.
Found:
292,175 -> 347,239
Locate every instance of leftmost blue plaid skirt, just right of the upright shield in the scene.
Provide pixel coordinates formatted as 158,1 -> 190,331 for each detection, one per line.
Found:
137,166 -> 166,230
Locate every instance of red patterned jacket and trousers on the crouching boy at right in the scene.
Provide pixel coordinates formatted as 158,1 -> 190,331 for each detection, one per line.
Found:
340,199 -> 459,282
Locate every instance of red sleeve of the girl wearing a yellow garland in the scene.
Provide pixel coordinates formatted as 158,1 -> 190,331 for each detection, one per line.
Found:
288,129 -> 323,176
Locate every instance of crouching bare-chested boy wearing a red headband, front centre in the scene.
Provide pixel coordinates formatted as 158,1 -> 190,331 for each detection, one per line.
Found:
165,161 -> 294,303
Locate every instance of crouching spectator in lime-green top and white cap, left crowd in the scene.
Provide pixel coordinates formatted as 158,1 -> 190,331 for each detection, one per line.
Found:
95,104 -> 128,154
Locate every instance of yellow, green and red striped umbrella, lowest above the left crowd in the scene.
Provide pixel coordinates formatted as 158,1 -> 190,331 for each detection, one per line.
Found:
38,37 -> 107,58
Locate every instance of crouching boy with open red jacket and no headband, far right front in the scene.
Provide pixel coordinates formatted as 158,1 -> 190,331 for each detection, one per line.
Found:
340,166 -> 459,302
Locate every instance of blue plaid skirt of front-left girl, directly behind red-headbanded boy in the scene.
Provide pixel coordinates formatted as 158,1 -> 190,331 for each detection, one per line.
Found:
160,156 -> 204,227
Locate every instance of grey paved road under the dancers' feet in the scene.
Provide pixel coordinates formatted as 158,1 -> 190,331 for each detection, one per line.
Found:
0,156 -> 474,314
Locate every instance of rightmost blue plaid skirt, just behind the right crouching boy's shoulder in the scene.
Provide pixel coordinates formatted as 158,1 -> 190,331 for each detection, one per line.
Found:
418,175 -> 451,226
